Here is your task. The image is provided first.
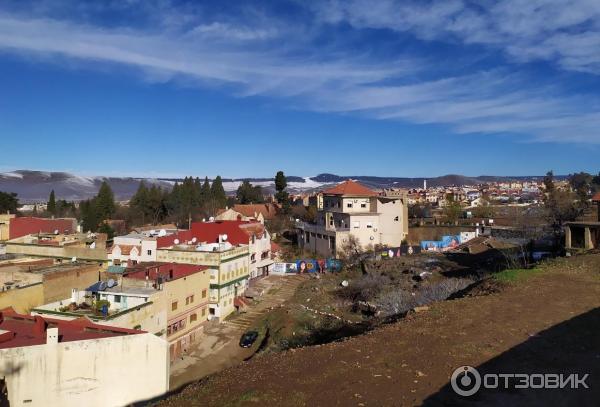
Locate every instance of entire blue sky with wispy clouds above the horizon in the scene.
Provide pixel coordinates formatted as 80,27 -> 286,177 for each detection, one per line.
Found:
0,0 -> 600,177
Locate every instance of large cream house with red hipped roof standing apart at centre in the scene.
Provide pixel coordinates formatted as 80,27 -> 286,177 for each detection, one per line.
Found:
298,180 -> 408,256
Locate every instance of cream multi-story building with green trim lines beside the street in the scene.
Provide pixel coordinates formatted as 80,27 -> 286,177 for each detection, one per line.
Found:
156,233 -> 250,320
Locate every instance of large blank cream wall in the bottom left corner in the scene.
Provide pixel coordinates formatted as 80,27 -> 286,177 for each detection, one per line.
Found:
0,334 -> 169,407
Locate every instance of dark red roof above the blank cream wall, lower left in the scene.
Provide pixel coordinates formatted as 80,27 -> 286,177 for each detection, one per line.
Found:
0,308 -> 144,349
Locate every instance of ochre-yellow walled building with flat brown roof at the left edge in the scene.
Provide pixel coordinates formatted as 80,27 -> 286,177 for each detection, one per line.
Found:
0,262 -> 101,312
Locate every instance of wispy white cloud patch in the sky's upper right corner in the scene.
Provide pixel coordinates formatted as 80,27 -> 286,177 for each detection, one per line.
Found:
311,0 -> 600,74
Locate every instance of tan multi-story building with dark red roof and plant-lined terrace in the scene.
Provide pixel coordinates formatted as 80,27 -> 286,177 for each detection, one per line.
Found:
32,262 -> 210,359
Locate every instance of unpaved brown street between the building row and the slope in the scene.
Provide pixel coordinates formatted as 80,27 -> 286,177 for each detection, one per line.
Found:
170,276 -> 304,389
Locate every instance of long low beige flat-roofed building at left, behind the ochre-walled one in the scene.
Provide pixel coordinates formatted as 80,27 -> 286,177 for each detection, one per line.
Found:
6,231 -> 108,263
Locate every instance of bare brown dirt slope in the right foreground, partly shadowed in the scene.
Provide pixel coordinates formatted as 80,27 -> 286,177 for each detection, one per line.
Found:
160,254 -> 600,406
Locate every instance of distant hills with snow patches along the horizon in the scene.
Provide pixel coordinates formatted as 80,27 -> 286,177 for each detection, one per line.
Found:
0,170 -> 565,203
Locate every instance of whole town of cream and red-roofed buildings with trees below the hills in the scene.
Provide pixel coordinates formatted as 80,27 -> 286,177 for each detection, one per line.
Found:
0,171 -> 600,405
